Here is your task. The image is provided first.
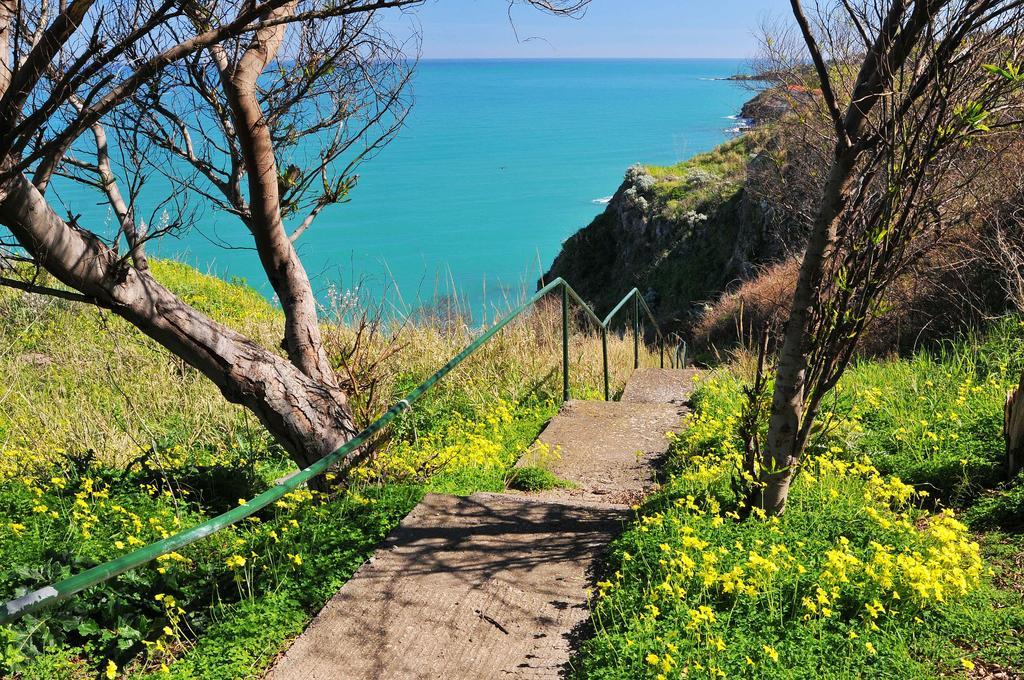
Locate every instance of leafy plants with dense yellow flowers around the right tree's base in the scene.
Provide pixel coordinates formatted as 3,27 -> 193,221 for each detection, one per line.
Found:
579,357 -> 1024,678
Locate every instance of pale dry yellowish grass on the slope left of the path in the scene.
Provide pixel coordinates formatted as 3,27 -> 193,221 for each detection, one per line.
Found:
0,263 -> 657,472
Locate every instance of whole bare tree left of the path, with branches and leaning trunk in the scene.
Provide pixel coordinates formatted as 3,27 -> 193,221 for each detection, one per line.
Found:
0,0 -> 583,489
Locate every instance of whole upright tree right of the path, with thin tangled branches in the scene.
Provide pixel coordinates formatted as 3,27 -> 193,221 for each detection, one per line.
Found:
758,0 -> 1024,513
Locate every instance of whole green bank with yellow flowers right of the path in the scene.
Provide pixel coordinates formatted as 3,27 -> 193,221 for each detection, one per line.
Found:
577,318 -> 1024,679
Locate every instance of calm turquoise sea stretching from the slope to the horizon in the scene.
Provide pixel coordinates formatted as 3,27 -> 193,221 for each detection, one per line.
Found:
54,59 -> 752,321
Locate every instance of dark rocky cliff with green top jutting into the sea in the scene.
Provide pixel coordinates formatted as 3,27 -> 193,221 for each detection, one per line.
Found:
545,132 -> 793,330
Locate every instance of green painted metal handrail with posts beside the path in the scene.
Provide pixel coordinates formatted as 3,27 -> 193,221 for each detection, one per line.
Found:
6,278 -> 678,625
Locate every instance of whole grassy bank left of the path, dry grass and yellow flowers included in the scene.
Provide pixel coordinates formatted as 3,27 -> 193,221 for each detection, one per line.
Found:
0,261 -> 653,679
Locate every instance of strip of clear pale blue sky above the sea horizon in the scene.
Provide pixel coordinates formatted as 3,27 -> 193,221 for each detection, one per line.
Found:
387,0 -> 790,58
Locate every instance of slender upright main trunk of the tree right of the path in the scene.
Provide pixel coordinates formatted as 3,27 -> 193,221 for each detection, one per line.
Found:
760,150 -> 856,514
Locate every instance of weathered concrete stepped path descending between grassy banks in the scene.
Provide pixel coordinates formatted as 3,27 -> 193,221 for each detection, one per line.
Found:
268,369 -> 692,680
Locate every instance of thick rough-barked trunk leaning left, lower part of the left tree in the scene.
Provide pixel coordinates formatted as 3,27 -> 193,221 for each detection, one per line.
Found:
0,165 -> 355,486
